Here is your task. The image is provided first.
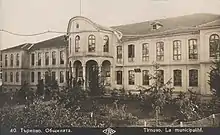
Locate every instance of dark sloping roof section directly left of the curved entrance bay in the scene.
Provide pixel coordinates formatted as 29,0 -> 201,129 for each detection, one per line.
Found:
30,35 -> 68,50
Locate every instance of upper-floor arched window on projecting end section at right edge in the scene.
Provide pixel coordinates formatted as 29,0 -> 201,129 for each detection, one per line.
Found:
209,34 -> 220,57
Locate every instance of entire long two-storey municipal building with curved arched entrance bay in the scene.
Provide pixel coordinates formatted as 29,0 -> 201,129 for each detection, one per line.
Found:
2,14 -> 220,94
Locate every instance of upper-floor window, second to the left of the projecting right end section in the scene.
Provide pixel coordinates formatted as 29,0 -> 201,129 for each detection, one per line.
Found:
173,40 -> 181,60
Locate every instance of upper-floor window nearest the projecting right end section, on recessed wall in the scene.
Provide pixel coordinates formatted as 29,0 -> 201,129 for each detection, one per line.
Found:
188,39 -> 198,59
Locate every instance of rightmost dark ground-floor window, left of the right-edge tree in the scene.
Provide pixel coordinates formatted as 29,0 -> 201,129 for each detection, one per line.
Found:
189,69 -> 198,87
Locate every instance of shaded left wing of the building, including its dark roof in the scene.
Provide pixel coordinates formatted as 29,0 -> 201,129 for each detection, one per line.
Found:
2,36 -> 67,91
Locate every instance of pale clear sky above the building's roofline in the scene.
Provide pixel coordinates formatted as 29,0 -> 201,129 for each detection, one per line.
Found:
0,0 -> 220,49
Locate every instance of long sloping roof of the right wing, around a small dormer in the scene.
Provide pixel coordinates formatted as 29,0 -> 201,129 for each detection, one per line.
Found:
111,13 -> 220,41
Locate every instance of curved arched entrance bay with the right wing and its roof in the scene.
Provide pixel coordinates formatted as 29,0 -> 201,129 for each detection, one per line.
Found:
67,14 -> 220,94
